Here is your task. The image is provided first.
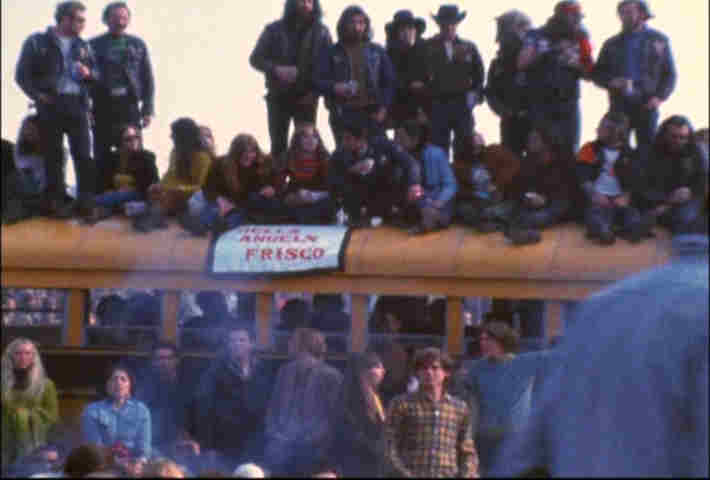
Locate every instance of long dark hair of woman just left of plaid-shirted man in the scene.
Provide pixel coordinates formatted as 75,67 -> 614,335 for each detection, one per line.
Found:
340,352 -> 382,423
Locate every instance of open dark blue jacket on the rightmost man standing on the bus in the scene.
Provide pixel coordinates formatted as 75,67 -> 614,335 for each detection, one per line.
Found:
591,28 -> 676,102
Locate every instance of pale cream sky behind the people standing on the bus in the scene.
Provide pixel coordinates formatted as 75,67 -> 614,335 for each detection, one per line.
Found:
1,0 -> 710,182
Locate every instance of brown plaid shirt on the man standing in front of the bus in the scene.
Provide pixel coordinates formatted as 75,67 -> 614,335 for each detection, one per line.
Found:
386,392 -> 478,477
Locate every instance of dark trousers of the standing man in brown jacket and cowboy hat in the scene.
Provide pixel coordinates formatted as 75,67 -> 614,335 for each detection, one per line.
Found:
430,95 -> 475,152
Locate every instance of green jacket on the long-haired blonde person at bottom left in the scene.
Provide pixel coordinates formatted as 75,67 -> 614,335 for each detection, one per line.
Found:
2,379 -> 59,465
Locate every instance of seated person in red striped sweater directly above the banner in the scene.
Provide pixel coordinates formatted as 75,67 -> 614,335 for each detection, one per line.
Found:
284,123 -> 335,224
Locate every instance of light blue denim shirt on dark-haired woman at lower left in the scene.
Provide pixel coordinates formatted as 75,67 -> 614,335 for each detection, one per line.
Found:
81,399 -> 151,457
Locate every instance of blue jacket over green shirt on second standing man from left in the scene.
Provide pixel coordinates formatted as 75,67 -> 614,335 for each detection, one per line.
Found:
89,33 -> 155,116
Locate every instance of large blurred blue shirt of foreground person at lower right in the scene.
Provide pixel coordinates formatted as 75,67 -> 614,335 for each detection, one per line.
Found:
490,235 -> 708,477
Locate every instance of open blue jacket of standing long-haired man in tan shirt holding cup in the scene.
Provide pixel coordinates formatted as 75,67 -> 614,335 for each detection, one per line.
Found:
313,43 -> 397,110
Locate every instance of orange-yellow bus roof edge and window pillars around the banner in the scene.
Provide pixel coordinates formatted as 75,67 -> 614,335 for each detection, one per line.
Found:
2,219 -> 670,355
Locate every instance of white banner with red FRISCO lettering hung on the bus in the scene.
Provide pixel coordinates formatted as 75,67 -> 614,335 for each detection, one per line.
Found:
207,225 -> 350,276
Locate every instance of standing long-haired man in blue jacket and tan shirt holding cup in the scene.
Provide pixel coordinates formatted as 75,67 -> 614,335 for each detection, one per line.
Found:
313,5 -> 397,147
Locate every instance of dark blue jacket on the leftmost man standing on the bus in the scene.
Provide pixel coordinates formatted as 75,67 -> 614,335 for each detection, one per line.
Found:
15,27 -> 100,108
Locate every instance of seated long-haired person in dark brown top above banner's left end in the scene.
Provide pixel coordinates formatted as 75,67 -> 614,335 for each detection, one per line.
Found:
180,133 -> 283,235
